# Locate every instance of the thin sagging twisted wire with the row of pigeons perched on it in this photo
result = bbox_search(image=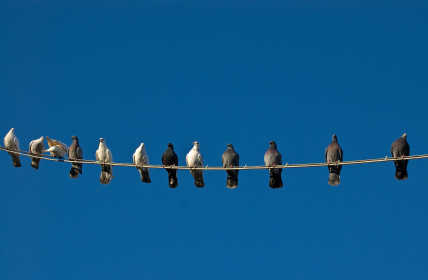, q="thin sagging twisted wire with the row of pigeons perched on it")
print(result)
[0,147,428,171]
